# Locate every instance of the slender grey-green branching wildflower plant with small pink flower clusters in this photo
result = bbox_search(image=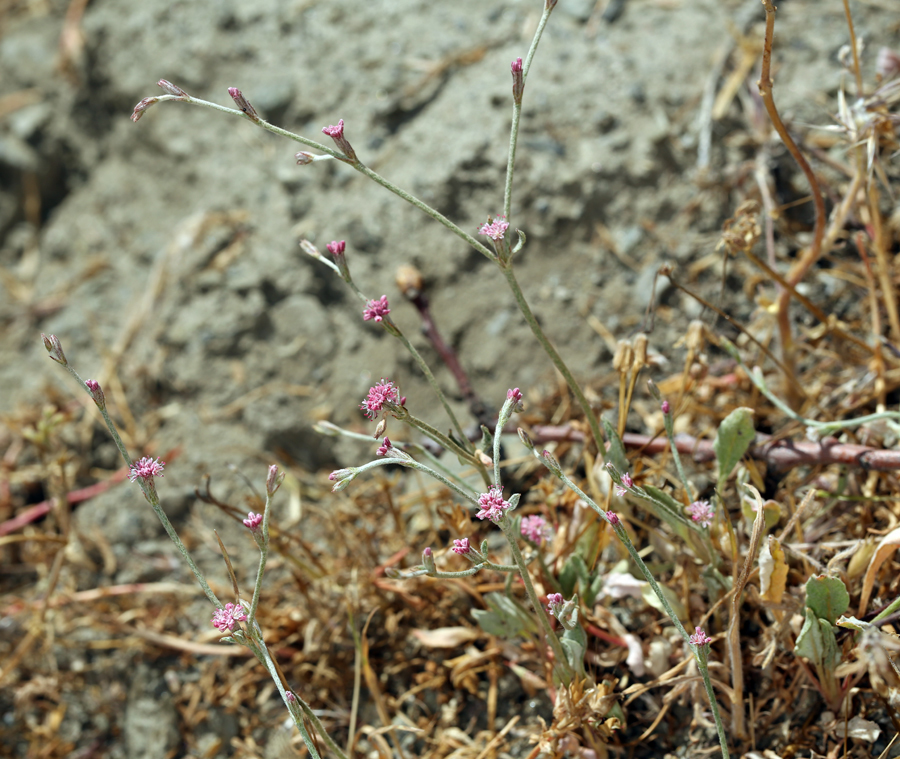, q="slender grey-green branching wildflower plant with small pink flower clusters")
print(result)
[38,0,752,759]
